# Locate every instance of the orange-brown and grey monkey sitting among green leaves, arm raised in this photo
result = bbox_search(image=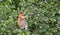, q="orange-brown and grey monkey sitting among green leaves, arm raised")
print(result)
[18,12,28,30]
